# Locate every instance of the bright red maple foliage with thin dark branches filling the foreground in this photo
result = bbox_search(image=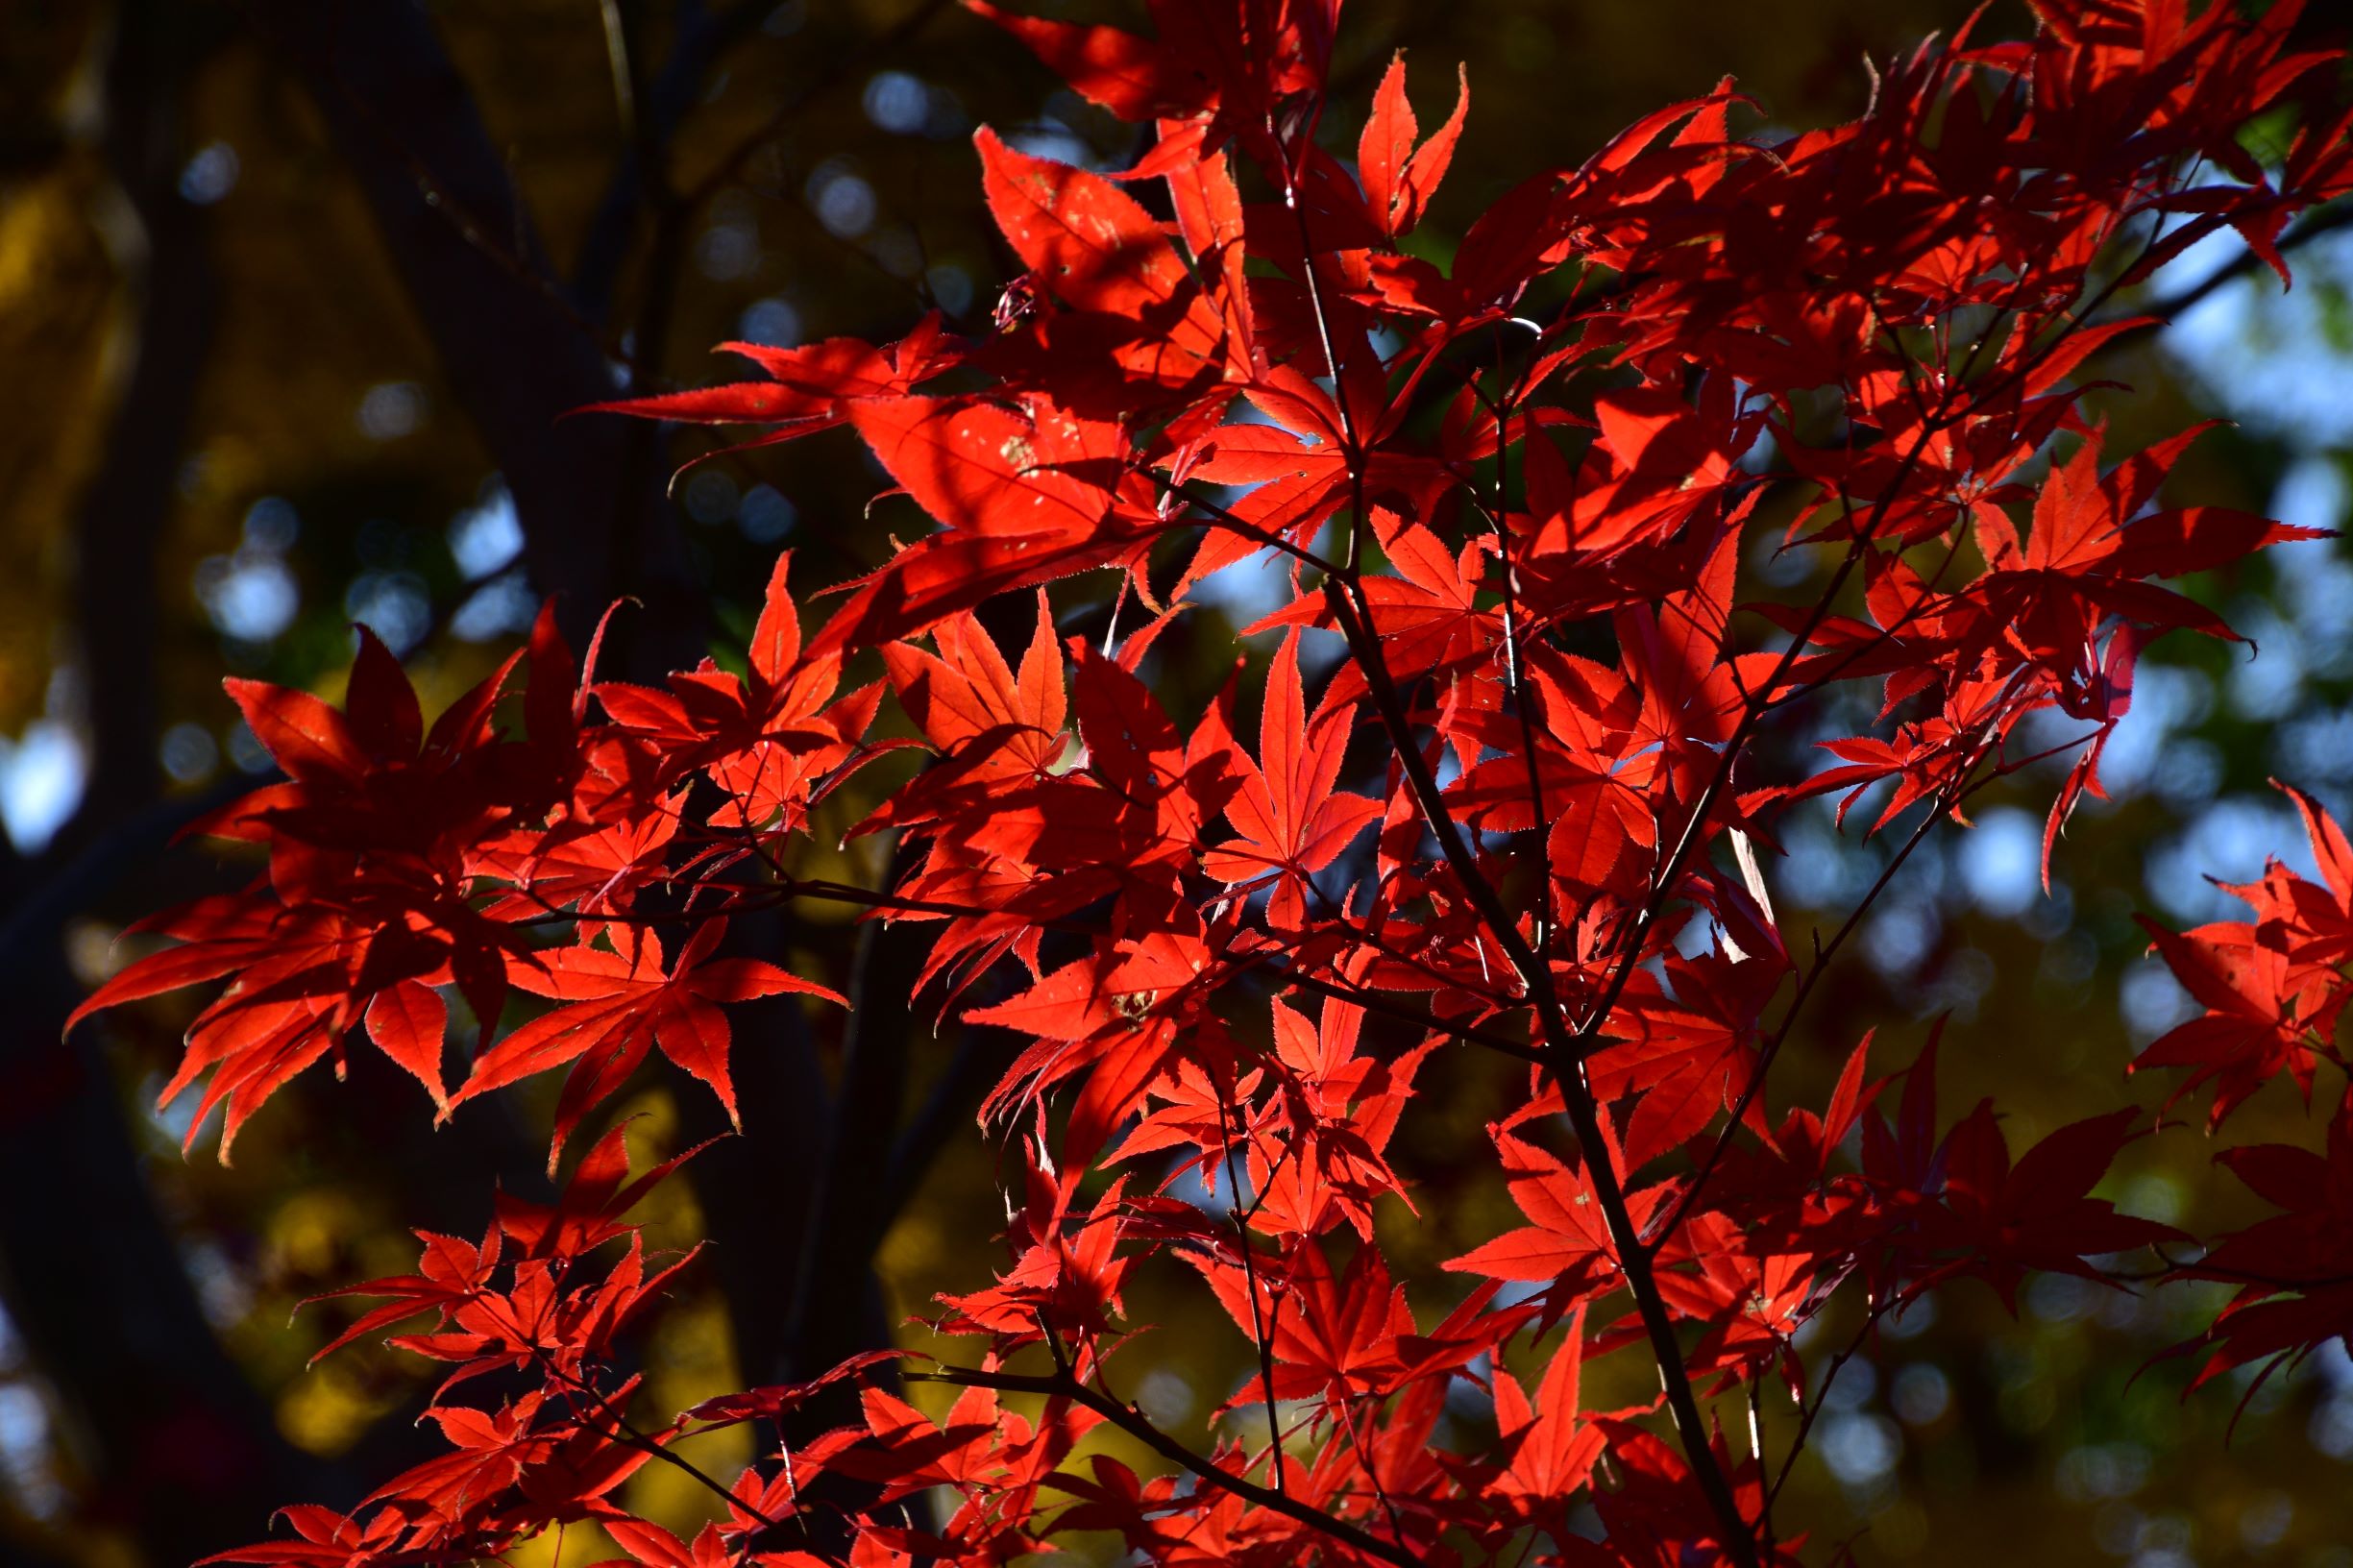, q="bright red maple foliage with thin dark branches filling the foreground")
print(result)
[73,0,2353,1568]
